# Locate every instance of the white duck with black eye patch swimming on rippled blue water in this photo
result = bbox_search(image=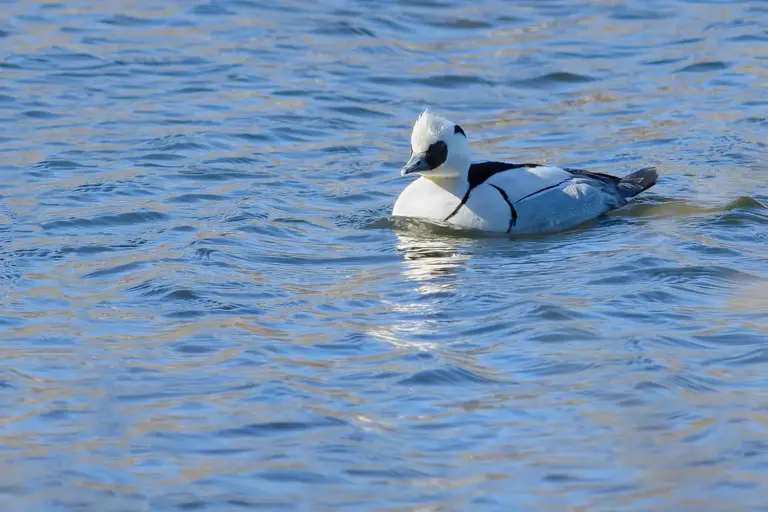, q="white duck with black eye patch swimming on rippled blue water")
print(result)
[392,109,659,234]
